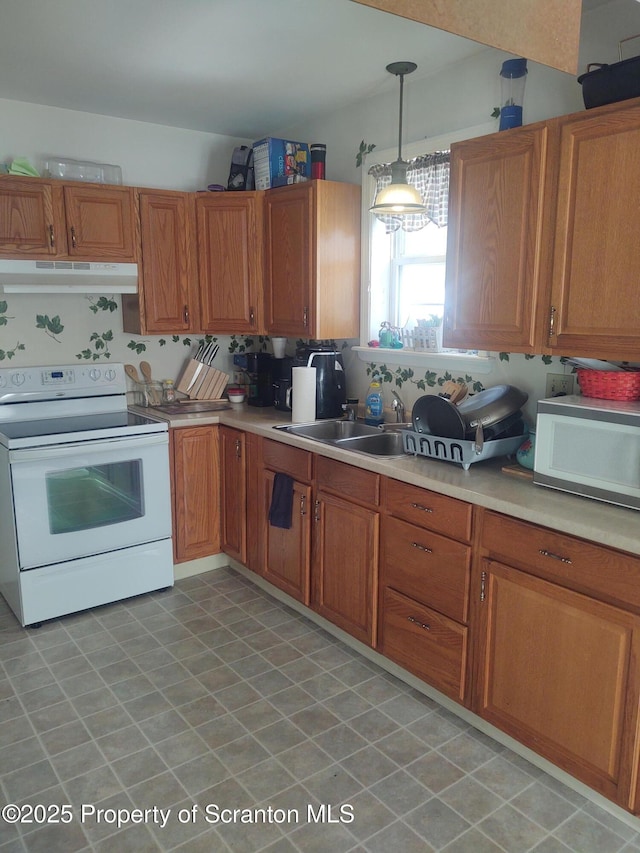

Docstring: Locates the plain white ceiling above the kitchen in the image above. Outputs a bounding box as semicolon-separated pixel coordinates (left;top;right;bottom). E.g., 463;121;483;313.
0;0;607;139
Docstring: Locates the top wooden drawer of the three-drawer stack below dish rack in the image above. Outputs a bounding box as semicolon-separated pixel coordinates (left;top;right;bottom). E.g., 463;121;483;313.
386;479;472;542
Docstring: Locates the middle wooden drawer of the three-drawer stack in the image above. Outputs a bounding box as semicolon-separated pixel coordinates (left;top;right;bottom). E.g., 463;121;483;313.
382;510;471;622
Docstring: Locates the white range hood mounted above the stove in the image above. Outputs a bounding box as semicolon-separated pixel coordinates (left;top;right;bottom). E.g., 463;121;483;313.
0;260;138;294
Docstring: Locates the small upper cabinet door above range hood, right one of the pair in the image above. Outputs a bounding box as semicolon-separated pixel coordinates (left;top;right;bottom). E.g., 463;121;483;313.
64;184;138;263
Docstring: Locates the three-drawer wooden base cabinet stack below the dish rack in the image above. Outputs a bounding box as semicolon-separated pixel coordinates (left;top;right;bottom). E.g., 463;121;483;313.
378;480;473;704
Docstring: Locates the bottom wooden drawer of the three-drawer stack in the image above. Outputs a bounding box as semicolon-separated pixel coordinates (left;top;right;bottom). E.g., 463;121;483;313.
379;588;467;702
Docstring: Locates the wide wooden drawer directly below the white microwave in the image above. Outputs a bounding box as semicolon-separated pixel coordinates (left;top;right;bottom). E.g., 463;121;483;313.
482;512;640;612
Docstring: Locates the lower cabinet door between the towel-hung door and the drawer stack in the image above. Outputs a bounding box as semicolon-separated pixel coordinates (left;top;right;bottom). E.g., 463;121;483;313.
312;492;380;646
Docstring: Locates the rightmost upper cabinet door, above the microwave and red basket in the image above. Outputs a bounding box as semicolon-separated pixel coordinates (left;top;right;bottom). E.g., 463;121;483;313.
550;103;640;359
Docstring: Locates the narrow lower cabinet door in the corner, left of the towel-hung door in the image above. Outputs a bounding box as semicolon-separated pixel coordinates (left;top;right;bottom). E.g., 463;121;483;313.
220;426;247;563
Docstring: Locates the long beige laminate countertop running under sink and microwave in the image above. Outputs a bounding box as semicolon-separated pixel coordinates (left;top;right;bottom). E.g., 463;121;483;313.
132;403;640;555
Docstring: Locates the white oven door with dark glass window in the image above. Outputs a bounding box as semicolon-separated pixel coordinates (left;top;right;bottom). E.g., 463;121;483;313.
9;432;171;570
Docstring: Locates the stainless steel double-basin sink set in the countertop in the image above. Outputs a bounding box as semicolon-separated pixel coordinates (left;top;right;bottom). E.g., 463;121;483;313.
275;420;405;456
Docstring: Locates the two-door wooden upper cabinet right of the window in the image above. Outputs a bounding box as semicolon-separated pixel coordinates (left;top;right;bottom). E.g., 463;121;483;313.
444;100;640;359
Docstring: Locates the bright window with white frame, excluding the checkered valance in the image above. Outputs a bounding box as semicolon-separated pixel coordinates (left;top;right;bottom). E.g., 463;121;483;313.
361;123;495;346
